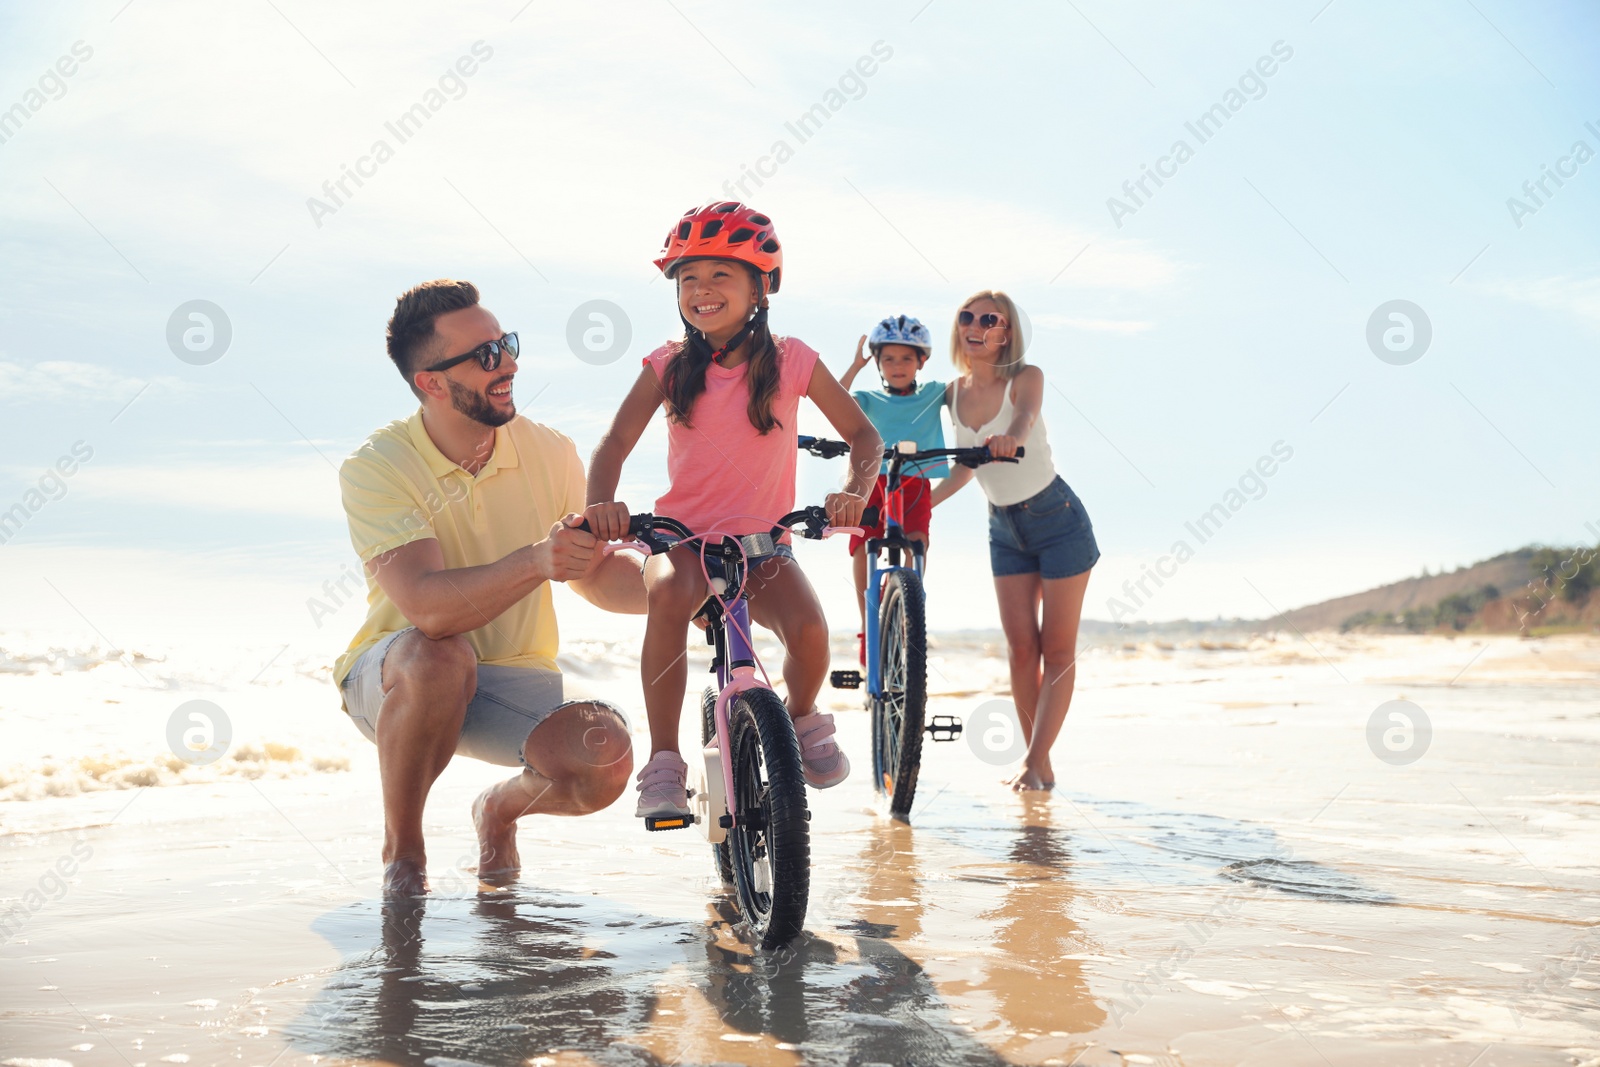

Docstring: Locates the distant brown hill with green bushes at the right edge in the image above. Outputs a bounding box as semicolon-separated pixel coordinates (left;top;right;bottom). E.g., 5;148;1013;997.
1267;545;1600;633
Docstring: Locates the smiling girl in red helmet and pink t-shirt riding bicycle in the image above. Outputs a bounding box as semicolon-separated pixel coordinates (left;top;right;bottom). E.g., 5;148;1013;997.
584;202;882;817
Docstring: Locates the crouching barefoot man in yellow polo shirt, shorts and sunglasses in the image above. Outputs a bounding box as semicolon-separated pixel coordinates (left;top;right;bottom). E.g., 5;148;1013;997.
333;280;645;896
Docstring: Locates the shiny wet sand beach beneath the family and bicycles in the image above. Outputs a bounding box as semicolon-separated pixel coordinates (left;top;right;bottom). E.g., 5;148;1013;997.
0;635;1600;1067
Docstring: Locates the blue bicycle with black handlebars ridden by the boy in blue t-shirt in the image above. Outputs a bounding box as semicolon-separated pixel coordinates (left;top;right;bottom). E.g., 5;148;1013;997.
798;435;1022;822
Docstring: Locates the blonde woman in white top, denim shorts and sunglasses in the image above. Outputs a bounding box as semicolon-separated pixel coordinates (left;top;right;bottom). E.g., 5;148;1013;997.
933;290;1099;790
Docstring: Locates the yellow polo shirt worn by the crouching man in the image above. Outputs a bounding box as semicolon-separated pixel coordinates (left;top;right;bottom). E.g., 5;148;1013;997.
333;410;584;683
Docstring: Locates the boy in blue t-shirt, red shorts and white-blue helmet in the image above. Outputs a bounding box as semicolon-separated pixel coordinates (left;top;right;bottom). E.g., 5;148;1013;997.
838;315;950;667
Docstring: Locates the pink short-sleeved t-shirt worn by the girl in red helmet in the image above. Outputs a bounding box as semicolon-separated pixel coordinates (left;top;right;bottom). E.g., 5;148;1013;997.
645;338;818;534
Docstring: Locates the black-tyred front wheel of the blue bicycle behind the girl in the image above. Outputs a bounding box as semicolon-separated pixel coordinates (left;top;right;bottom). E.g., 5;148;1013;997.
872;568;928;822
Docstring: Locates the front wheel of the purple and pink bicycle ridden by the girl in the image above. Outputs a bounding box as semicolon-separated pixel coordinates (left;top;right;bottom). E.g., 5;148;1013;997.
728;689;811;949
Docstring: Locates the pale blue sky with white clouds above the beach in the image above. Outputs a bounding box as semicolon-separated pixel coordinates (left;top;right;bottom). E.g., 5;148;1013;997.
0;0;1600;651
